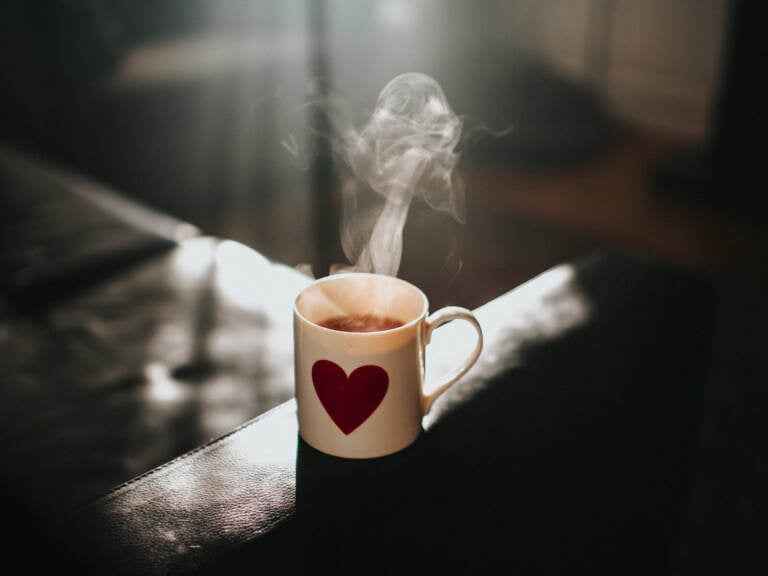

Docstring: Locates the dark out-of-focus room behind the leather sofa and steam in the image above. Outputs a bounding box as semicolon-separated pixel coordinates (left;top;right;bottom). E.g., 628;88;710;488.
0;0;768;573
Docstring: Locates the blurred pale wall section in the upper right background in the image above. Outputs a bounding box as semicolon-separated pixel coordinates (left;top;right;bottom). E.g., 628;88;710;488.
504;0;728;139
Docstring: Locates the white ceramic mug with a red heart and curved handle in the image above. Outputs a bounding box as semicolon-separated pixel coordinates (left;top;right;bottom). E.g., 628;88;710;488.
294;273;483;458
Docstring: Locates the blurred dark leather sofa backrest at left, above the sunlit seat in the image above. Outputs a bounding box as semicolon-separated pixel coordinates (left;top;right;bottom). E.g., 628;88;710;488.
0;143;198;307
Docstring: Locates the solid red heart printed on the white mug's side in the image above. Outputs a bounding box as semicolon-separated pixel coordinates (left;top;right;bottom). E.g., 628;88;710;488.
312;360;389;434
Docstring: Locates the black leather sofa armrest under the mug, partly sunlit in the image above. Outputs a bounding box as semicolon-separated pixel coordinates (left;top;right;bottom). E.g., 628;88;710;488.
61;249;712;574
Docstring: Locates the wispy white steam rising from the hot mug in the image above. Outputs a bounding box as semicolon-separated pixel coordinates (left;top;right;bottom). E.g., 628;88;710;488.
334;73;464;276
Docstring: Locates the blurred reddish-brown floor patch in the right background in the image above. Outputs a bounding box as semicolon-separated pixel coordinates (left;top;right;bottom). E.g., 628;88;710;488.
472;131;766;274
